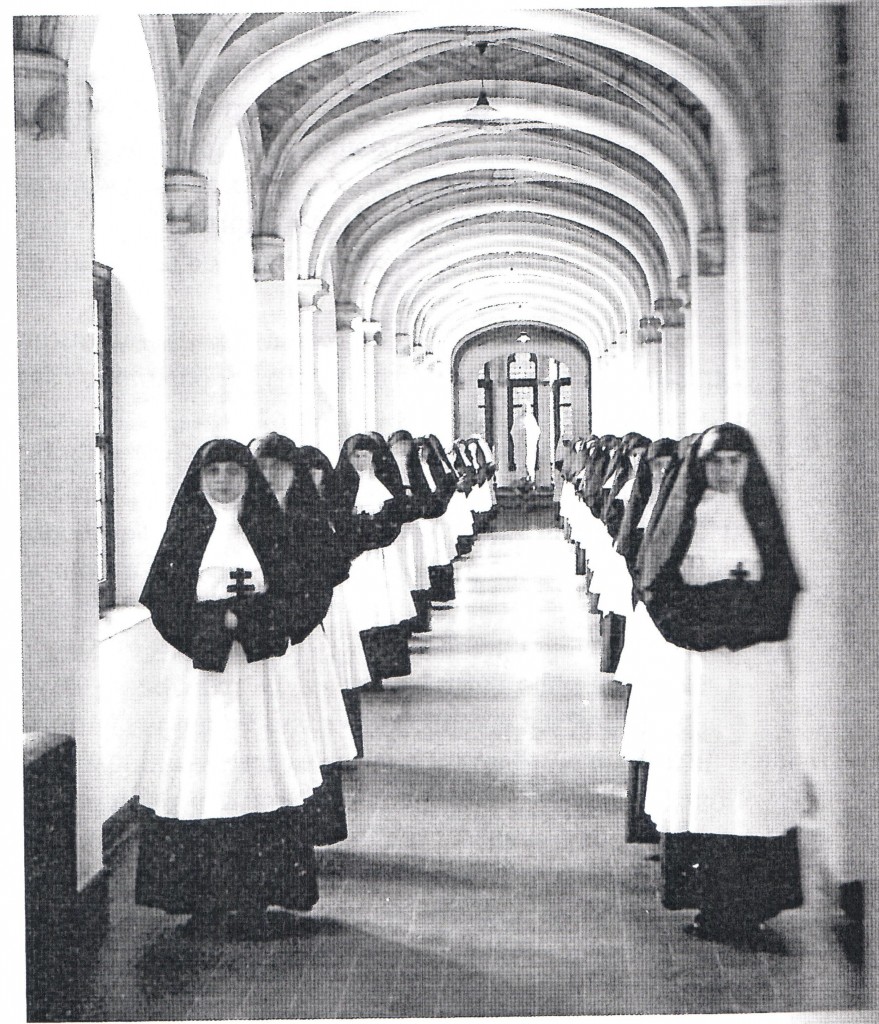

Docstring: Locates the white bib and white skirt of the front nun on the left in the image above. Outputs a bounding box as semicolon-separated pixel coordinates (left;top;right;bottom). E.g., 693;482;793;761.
138;502;325;819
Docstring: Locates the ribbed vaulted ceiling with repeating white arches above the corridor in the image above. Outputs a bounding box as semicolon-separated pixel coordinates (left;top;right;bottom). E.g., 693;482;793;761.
160;6;773;352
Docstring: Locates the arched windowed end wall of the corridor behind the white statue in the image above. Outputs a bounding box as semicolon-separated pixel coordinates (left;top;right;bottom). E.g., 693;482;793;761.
452;322;592;487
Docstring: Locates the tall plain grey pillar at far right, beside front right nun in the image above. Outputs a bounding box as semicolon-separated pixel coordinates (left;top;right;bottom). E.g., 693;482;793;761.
767;6;852;929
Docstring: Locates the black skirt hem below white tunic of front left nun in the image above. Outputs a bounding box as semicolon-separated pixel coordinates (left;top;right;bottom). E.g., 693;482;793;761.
134;807;318;913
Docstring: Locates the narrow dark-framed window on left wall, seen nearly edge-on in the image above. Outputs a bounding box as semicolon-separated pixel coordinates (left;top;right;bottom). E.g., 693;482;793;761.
92;262;116;614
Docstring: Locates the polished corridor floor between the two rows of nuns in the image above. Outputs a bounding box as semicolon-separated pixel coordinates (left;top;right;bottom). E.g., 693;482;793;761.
82;517;861;1020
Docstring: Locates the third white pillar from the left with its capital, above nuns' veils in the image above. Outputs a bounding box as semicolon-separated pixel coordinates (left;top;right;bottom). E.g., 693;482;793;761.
245;234;301;440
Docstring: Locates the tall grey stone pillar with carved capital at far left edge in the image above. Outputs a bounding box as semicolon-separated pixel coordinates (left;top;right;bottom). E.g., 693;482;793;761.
16;39;101;886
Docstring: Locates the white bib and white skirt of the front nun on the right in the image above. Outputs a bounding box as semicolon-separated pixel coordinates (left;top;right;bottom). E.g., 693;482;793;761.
646;489;806;837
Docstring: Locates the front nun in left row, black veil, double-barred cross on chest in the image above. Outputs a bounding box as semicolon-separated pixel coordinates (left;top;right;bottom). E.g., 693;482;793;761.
135;439;322;934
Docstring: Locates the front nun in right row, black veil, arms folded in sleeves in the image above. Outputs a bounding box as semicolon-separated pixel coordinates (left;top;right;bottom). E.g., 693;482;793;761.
639;423;806;947
